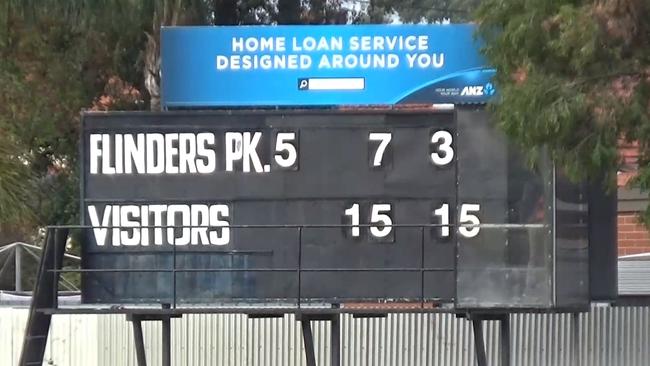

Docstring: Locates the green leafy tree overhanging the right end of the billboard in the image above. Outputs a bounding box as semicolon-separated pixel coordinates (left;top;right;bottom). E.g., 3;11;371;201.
470;0;650;223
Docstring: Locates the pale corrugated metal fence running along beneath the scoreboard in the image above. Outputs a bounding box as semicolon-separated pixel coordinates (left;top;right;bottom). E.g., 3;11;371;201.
0;307;650;366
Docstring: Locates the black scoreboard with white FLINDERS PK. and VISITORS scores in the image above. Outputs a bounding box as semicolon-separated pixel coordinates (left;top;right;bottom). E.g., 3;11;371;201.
82;109;604;307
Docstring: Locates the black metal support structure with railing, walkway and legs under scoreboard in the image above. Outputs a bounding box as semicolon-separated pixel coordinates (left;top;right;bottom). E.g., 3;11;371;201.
19;224;596;366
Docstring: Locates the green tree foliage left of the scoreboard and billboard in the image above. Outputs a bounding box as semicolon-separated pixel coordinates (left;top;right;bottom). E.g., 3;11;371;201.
0;1;144;234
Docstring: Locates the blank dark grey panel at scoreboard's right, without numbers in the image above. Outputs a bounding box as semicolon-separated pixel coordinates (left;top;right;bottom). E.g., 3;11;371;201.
457;110;554;308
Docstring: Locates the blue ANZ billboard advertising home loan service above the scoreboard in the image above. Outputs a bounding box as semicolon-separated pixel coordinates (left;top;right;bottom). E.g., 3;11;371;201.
161;24;495;108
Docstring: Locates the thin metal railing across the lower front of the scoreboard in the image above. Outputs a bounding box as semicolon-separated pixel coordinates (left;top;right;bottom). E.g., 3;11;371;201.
41;223;549;313
